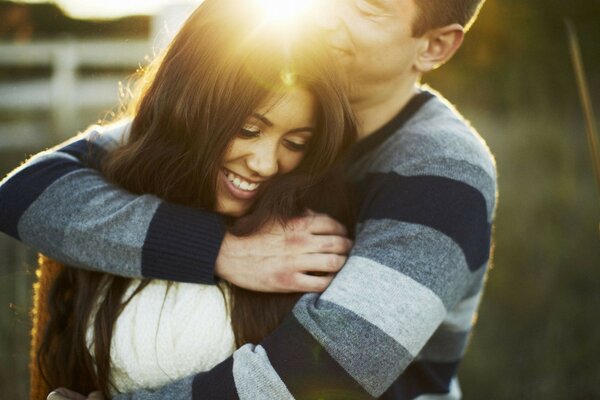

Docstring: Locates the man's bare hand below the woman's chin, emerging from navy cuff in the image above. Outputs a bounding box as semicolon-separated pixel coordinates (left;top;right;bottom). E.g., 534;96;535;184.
215;212;352;293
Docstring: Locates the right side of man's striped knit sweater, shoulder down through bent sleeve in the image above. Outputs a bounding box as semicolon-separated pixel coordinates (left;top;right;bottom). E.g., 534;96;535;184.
186;91;496;400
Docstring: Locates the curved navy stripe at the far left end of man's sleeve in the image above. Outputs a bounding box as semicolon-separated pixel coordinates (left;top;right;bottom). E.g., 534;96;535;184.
0;159;82;240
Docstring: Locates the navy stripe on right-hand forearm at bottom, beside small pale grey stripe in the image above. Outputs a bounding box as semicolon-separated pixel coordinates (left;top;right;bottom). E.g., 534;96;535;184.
261;316;373;400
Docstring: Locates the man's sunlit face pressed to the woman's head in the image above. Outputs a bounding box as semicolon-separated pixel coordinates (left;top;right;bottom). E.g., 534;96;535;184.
315;0;419;95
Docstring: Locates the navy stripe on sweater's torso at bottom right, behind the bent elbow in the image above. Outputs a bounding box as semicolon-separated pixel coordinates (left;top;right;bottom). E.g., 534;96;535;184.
380;361;460;400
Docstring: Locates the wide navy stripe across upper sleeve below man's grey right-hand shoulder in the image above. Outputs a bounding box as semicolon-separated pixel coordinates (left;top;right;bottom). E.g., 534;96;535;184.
356;172;492;271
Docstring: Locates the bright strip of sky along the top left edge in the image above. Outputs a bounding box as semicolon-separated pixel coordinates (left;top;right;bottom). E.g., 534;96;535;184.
21;0;202;18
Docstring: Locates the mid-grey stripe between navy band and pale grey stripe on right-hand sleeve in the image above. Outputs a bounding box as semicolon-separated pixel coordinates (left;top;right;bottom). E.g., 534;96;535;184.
354;220;479;309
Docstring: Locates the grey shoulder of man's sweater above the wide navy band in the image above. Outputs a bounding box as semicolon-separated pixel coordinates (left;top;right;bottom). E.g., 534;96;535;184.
351;93;497;218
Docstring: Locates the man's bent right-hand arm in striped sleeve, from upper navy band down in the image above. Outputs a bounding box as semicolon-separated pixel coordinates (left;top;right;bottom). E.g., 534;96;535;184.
108;148;496;400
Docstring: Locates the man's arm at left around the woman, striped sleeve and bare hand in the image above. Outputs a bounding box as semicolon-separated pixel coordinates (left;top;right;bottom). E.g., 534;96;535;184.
0;121;351;292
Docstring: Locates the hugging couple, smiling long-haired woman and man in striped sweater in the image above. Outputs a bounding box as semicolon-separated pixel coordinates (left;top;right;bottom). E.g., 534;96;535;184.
0;0;496;399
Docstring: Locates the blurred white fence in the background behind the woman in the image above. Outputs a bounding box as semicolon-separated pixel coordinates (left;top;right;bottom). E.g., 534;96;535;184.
0;39;152;149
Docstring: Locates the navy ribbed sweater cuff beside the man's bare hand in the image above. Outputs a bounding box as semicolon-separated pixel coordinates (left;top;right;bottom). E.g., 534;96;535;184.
142;203;225;285
